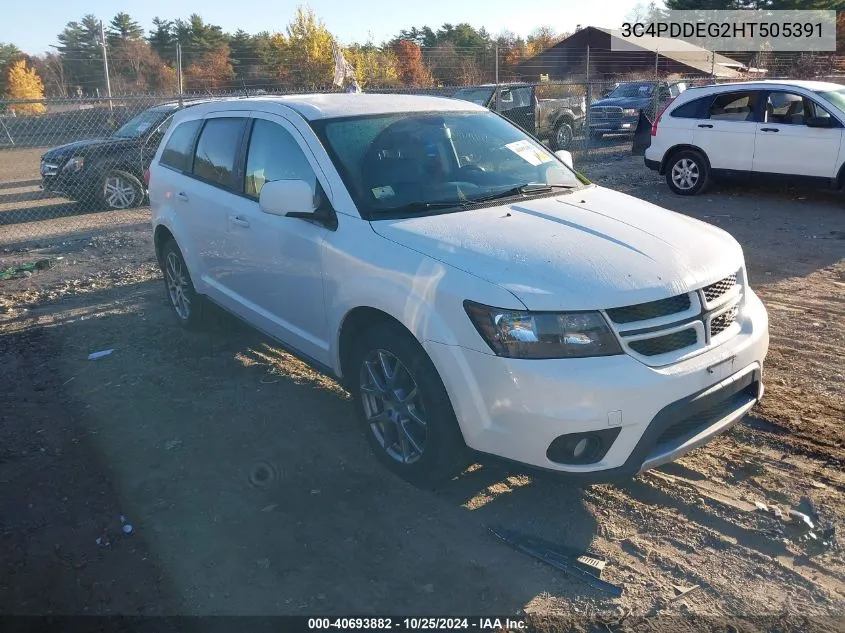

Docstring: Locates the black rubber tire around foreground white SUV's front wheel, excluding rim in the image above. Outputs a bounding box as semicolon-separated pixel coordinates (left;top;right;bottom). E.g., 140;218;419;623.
348;323;470;488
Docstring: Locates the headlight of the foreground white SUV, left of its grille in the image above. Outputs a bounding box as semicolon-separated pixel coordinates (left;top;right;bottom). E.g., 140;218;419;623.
464;301;622;358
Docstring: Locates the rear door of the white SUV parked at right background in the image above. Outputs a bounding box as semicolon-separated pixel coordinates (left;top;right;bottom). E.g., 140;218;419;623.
693;90;761;172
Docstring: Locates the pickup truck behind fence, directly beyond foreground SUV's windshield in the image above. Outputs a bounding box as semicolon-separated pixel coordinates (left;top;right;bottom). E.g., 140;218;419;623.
454;83;587;150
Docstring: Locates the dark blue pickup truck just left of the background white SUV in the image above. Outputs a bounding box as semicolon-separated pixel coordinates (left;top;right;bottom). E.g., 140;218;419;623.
590;81;686;138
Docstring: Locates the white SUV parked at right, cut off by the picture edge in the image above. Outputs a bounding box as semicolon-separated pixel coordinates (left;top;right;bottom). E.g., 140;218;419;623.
645;81;845;195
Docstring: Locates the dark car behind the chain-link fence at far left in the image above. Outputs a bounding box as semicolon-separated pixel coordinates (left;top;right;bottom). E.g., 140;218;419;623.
41;102;207;209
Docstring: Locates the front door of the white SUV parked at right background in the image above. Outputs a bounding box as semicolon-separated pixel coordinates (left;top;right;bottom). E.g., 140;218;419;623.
754;90;843;178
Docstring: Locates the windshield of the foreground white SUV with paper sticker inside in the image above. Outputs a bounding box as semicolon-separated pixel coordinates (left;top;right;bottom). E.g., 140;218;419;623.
314;112;588;219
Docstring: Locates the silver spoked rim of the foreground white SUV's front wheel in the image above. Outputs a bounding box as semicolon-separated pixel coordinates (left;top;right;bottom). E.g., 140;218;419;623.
360;349;428;464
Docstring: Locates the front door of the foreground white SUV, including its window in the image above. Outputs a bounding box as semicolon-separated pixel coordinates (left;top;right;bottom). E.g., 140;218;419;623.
219;113;330;364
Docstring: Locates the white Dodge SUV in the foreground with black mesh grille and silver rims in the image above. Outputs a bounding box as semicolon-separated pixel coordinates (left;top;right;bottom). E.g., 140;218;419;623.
147;94;769;484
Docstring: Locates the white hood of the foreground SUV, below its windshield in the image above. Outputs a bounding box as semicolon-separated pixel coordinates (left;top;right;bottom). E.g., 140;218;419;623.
371;186;743;310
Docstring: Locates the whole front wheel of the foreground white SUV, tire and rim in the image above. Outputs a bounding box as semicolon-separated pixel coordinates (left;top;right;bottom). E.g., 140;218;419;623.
350;324;469;487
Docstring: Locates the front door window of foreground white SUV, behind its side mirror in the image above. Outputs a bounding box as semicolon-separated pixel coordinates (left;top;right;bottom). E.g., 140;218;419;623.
244;119;317;198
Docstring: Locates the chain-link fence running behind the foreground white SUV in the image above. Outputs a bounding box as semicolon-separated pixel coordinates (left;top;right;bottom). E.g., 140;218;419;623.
0;74;840;247
